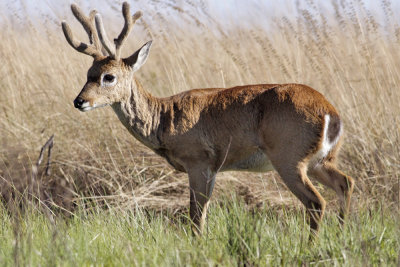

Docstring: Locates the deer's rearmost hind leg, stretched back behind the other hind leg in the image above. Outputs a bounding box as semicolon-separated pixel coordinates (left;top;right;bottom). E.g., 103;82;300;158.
309;162;354;222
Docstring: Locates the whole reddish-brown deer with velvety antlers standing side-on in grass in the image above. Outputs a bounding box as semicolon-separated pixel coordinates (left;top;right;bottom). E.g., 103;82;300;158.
62;2;354;235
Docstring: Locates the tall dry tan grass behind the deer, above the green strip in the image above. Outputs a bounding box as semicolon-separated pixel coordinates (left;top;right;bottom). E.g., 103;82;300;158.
0;0;400;214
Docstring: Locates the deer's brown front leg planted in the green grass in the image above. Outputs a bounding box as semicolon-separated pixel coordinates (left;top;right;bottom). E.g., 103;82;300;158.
188;168;216;235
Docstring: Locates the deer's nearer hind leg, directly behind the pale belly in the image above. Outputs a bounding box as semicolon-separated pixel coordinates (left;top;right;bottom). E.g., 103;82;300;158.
275;162;326;234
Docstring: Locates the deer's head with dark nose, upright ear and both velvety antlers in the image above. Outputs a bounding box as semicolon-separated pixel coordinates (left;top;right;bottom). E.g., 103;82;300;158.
62;2;152;111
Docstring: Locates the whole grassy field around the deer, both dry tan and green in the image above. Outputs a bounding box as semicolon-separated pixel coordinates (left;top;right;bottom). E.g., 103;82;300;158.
0;0;400;266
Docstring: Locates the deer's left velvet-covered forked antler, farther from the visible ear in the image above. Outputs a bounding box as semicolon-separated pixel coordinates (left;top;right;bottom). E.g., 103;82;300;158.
61;4;103;58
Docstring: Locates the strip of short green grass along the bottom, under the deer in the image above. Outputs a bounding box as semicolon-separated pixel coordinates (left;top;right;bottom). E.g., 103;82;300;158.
0;198;400;266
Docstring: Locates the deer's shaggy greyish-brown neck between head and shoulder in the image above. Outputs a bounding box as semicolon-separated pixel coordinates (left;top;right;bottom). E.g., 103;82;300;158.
112;79;161;150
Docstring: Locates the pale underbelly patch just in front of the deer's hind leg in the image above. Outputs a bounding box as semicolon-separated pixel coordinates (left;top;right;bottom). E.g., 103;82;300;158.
226;150;274;172
